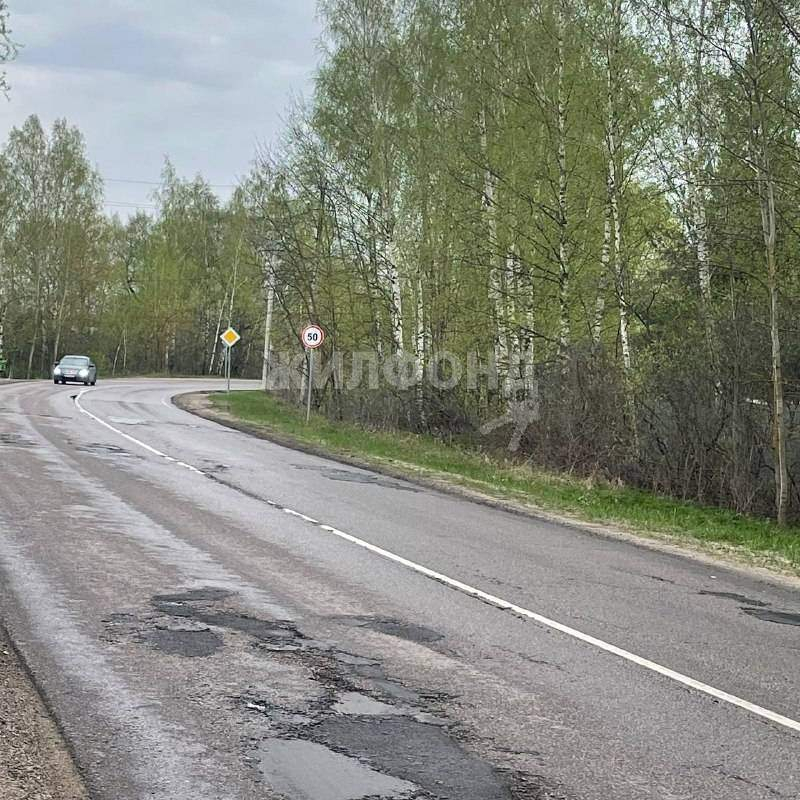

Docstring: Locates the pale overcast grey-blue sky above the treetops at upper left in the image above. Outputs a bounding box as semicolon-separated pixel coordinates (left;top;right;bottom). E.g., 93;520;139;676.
0;0;320;216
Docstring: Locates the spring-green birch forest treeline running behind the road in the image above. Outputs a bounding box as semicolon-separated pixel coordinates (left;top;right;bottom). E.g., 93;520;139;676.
0;0;800;522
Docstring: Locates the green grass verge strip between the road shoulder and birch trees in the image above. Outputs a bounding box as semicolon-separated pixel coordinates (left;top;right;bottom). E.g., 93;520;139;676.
211;391;800;575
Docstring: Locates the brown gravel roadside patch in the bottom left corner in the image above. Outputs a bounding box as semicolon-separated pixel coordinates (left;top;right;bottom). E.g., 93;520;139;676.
0;626;89;800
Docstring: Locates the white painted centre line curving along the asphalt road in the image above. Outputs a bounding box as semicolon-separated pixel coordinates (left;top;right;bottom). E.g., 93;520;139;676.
75;389;800;732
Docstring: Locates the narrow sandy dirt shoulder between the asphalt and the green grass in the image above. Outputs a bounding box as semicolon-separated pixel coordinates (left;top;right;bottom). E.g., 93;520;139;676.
172;391;800;590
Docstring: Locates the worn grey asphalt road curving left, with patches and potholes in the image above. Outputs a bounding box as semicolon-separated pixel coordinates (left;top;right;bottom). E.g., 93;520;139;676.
0;380;800;800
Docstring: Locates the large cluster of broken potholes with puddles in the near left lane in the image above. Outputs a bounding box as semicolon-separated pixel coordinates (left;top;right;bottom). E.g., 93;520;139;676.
133;587;560;800
